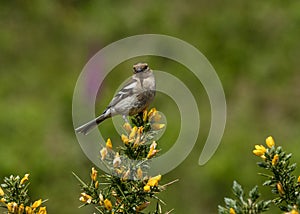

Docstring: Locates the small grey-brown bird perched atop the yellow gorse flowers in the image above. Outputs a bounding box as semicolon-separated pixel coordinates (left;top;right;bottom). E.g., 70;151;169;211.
75;63;155;135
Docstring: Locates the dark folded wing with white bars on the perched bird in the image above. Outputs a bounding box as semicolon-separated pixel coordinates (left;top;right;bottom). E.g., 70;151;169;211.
107;79;138;108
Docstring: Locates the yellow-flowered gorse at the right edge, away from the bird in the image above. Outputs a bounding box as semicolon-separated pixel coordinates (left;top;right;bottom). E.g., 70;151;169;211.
219;137;300;214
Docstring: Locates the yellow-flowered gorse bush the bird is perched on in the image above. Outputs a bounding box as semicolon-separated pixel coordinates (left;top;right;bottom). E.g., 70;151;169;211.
74;108;173;214
